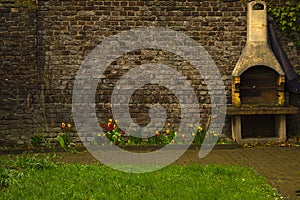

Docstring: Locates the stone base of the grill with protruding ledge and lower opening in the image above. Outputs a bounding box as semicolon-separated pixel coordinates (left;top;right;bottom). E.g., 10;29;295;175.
227;105;298;144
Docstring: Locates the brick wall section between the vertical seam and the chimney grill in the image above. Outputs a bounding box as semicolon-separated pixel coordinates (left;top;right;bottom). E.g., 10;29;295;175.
37;1;246;144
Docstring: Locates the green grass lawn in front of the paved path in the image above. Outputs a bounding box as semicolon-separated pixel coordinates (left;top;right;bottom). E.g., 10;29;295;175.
0;155;280;200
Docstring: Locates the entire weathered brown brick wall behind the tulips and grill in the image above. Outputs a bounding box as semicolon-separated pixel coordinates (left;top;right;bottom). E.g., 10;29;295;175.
0;0;300;147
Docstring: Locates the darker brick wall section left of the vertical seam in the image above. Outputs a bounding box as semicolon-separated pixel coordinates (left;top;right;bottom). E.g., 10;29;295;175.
0;1;38;146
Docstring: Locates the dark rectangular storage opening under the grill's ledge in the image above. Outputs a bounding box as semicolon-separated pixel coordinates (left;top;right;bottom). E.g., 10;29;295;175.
241;115;278;139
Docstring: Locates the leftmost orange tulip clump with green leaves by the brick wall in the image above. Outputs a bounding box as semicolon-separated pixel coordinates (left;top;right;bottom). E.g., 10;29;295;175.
56;122;75;150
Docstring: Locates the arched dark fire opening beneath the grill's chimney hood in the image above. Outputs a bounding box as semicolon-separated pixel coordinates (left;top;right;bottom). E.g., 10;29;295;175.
240;66;279;105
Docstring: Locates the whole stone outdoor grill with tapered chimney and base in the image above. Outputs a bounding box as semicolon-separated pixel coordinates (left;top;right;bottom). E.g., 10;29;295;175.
227;1;297;143
